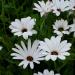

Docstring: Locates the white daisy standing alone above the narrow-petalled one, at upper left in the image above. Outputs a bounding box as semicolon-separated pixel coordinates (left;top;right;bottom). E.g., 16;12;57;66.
9;17;37;39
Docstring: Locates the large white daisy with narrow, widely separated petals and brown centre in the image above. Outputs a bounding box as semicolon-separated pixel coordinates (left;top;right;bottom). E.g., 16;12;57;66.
11;39;44;69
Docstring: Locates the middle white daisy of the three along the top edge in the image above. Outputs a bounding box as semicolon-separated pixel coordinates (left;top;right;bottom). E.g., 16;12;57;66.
52;0;70;16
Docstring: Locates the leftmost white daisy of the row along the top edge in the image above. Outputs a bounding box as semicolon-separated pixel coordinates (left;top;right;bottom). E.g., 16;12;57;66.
33;0;52;17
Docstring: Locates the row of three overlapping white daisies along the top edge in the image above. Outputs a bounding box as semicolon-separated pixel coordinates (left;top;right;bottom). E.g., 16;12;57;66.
33;0;75;17
